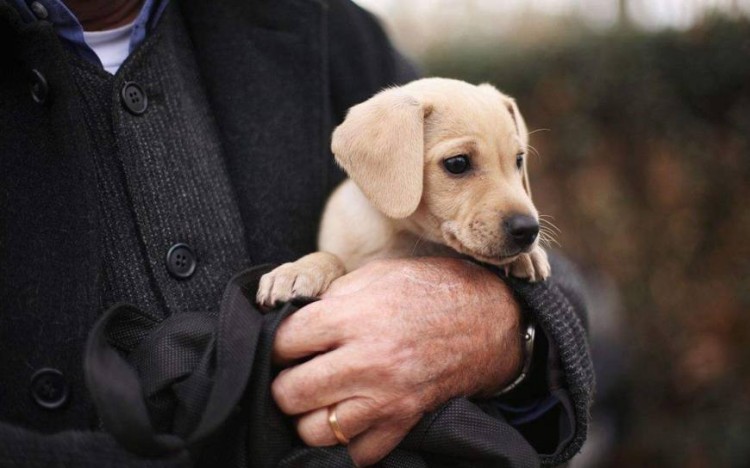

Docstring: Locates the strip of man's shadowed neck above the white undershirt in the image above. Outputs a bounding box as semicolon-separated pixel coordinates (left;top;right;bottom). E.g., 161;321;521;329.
64;0;143;31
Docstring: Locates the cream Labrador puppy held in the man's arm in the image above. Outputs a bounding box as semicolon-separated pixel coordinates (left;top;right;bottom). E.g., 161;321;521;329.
257;78;550;306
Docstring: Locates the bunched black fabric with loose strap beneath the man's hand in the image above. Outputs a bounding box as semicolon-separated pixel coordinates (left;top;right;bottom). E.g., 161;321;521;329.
85;266;539;468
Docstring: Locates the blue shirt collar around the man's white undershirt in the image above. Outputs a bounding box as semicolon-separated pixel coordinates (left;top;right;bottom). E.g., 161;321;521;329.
10;0;169;67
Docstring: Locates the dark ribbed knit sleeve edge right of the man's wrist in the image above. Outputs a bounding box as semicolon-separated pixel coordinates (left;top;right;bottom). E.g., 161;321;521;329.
508;255;594;465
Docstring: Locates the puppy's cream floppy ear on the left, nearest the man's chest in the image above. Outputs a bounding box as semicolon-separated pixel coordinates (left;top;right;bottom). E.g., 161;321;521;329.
331;88;426;218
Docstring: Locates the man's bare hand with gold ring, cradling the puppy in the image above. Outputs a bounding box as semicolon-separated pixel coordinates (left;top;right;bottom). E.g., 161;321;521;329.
272;258;521;465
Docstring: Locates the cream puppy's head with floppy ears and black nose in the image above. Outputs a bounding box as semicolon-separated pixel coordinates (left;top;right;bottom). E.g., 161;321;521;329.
331;78;539;265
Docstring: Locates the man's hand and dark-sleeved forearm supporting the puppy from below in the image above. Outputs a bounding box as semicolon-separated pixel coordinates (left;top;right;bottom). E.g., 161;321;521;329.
273;254;591;464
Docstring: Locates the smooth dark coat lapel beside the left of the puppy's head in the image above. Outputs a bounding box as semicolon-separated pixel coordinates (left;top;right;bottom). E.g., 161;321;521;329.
181;0;331;263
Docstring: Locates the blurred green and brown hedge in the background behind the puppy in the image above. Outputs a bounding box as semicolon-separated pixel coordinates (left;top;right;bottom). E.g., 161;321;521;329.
424;18;750;466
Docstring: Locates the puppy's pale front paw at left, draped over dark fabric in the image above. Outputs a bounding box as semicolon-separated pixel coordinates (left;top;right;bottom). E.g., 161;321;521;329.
255;252;346;307
